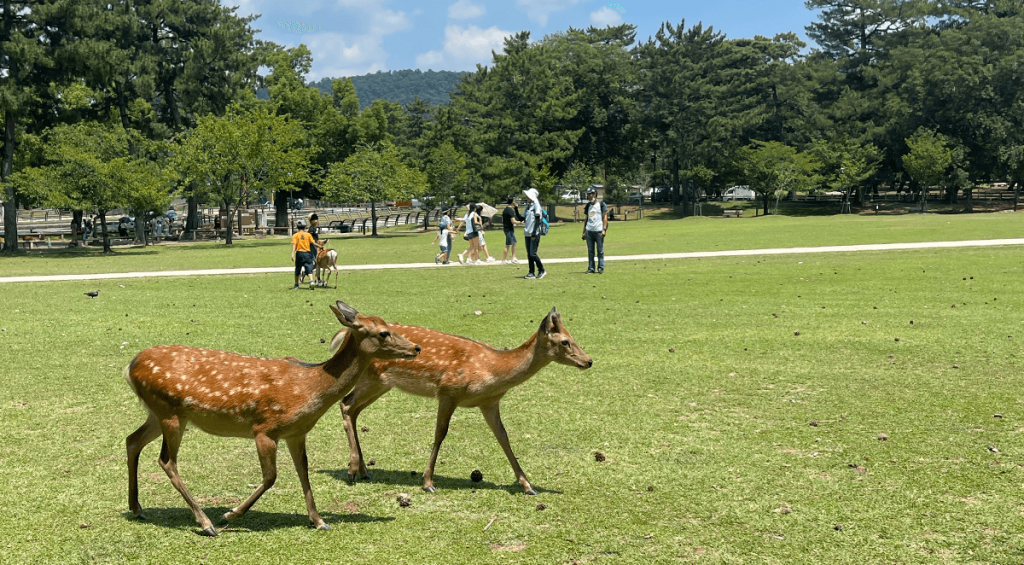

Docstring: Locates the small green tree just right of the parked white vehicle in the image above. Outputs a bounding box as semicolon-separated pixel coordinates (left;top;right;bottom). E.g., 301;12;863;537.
741;141;813;215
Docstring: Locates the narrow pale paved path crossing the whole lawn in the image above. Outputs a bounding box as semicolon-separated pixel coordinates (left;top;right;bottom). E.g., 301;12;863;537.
0;238;1024;284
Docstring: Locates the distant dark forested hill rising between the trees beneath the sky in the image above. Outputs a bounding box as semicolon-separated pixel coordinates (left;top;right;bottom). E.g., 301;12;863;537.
309;70;466;107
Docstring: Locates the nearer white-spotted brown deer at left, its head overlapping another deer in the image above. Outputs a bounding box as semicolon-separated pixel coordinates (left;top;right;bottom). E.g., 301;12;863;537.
125;301;421;536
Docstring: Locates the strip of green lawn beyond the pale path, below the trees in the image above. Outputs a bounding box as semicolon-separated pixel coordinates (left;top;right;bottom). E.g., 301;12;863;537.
0;213;1024;276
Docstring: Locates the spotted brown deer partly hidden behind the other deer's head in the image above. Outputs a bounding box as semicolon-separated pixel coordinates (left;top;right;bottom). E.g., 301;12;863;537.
332;308;594;494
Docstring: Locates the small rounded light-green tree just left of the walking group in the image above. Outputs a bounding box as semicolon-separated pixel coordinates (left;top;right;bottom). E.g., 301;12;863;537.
321;141;426;236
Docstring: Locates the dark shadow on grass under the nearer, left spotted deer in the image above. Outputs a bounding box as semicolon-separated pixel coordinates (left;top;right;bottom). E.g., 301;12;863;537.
121;507;394;533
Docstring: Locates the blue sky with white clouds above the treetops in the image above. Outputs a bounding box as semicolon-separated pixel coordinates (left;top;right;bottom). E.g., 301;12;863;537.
228;0;815;80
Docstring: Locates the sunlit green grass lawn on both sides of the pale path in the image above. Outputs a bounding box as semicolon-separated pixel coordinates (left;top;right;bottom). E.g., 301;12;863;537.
0;237;1024;564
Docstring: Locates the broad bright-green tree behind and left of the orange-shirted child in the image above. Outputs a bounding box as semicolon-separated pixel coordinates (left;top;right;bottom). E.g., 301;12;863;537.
174;102;313;245
